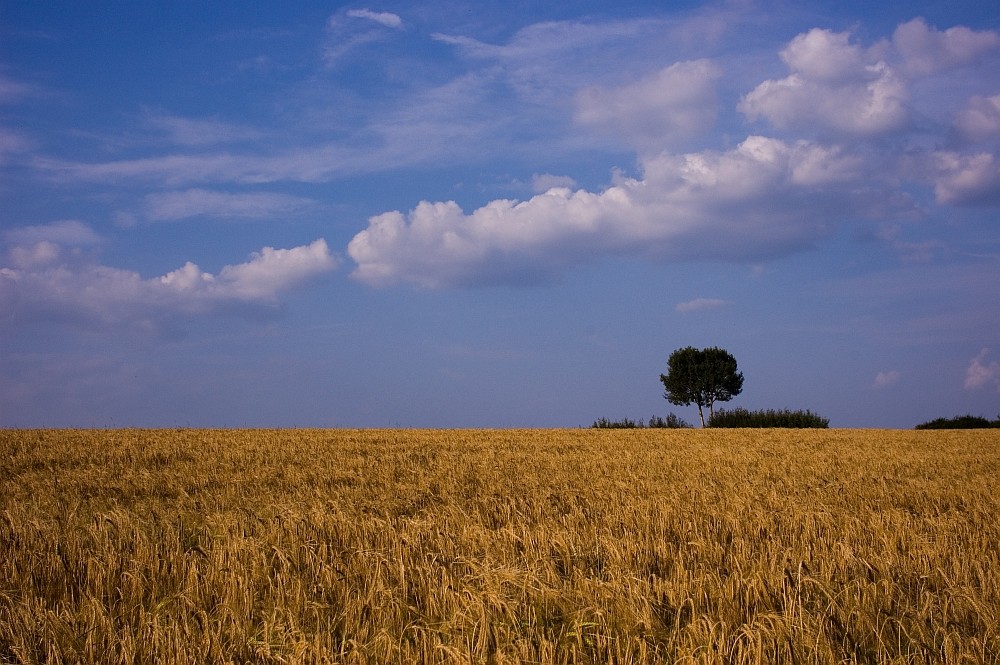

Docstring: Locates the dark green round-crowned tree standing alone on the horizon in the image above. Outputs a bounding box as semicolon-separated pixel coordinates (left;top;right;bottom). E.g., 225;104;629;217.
660;346;743;427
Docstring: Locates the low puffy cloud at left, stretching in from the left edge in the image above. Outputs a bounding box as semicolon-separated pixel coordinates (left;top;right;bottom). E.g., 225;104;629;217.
0;233;337;324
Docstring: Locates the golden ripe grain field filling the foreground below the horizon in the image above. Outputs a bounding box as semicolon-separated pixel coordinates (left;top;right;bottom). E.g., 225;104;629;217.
0;429;1000;664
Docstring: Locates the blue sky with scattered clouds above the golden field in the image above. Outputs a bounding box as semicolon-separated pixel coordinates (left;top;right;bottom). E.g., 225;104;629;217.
0;0;1000;427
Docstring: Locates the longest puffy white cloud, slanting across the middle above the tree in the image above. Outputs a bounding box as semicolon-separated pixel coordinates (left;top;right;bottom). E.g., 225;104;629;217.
348;136;858;288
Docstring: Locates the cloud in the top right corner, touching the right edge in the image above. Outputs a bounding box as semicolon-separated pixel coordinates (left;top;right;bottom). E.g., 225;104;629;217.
892;18;1000;76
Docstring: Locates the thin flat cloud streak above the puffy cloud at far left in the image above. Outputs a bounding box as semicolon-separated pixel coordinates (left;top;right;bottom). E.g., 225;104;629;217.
146;189;312;221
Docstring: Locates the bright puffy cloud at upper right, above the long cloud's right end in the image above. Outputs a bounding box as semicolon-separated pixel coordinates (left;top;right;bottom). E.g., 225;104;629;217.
738;28;909;136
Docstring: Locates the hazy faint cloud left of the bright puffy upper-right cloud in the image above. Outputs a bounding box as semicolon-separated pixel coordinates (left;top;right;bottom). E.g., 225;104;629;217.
574;60;721;153
